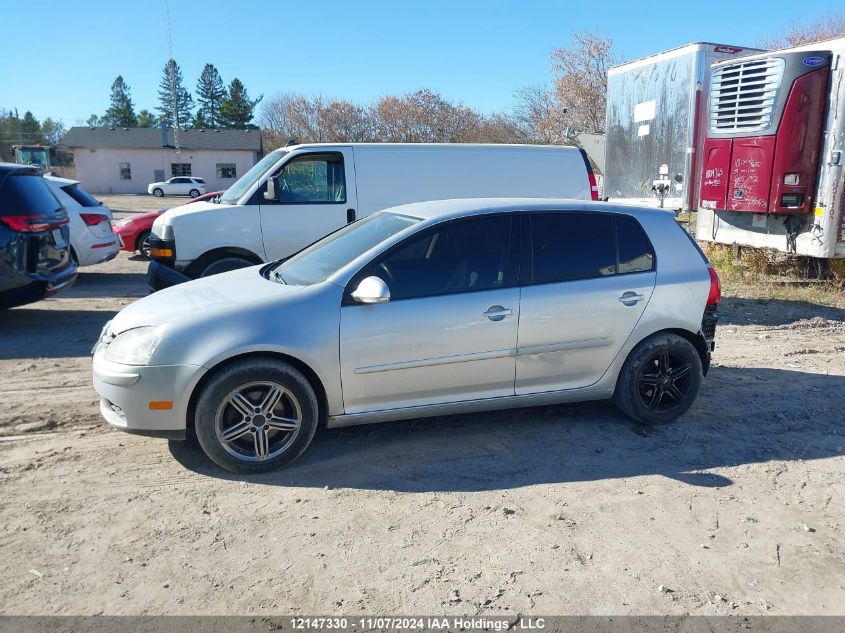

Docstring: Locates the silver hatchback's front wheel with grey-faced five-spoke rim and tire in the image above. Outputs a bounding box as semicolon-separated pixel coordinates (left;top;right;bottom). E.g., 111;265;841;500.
194;358;319;473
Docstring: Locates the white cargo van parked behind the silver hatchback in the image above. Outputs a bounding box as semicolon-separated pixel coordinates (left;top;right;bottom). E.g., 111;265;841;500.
148;143;598;290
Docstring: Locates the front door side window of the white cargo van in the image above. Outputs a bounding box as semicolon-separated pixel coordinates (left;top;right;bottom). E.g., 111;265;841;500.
278;153;346;204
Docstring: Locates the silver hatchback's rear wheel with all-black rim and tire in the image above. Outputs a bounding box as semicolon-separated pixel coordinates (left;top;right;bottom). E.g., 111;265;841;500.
613;333;704;424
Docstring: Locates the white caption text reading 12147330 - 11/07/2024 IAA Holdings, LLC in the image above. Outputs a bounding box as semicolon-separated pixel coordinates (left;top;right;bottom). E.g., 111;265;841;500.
290;616;546;631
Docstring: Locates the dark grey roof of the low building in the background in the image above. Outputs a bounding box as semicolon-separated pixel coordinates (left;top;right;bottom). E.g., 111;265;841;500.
59;127;261;152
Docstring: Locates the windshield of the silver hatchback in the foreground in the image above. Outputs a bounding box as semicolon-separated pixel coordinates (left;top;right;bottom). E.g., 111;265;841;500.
276;212;420;286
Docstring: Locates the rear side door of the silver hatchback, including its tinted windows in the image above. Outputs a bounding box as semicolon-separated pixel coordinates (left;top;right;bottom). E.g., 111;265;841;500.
516;210;656;395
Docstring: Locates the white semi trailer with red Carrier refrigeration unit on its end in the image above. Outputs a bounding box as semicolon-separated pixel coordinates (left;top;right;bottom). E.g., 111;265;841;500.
696;38;845;258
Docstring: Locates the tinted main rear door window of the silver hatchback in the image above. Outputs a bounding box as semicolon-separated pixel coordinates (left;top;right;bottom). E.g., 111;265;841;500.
530;213;616;284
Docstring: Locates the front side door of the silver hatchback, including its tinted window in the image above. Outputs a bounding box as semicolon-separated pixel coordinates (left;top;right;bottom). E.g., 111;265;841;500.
340;215;519;414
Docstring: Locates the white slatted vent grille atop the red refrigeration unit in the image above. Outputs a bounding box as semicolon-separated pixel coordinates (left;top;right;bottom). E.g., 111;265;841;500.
710;57;784;134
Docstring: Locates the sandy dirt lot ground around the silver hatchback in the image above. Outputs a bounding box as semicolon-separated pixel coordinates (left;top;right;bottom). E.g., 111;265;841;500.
0;199;845;615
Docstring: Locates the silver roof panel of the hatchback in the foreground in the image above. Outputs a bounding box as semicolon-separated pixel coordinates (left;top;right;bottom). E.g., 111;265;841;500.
385;198;674;220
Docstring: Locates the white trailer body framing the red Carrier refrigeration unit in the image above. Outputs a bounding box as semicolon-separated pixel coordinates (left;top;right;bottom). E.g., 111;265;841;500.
696;38;845;259
